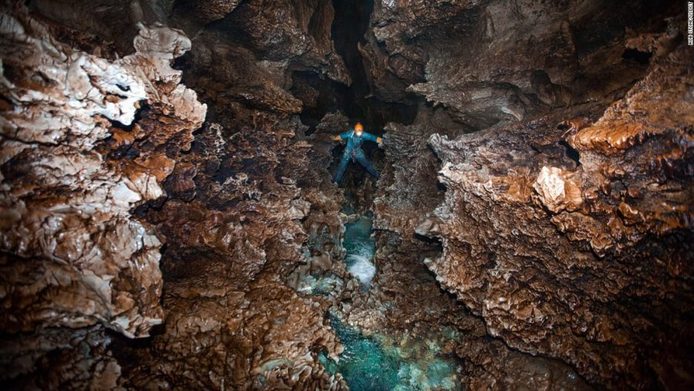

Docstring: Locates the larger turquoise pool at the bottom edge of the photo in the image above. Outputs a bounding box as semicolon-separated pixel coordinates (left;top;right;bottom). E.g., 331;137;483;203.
320;316;460;391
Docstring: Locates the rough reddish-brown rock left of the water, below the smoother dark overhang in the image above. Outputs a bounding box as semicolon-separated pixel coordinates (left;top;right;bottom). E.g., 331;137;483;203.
114;106;344;390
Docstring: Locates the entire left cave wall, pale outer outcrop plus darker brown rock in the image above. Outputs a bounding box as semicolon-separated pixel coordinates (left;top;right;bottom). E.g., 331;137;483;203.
1;1;349;390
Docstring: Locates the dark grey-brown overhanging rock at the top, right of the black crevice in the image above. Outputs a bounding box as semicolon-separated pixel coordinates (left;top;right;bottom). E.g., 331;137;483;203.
361;0;668;129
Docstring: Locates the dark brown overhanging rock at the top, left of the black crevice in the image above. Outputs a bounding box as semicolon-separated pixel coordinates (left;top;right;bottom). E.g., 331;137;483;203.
174;0;350;121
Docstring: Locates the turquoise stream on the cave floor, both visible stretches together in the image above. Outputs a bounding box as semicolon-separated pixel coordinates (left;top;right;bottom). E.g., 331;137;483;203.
320;213;460;391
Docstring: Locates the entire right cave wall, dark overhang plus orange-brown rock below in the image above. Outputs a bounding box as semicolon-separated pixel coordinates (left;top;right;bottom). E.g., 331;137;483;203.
362;1;692;388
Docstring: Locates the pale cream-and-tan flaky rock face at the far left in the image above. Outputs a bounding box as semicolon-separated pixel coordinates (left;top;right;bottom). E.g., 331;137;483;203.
0;2;206;388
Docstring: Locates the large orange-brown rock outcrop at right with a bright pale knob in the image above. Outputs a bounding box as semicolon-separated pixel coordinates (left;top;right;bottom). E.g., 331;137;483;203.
428;39;694;388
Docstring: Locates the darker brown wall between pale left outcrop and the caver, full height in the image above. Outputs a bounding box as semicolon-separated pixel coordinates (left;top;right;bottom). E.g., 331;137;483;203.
104;2;354;390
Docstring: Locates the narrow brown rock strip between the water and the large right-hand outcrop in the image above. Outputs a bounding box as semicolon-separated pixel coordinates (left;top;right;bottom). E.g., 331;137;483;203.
370;108;588;390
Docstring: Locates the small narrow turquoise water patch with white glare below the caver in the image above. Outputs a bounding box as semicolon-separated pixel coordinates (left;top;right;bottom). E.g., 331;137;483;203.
342;215;376;288
